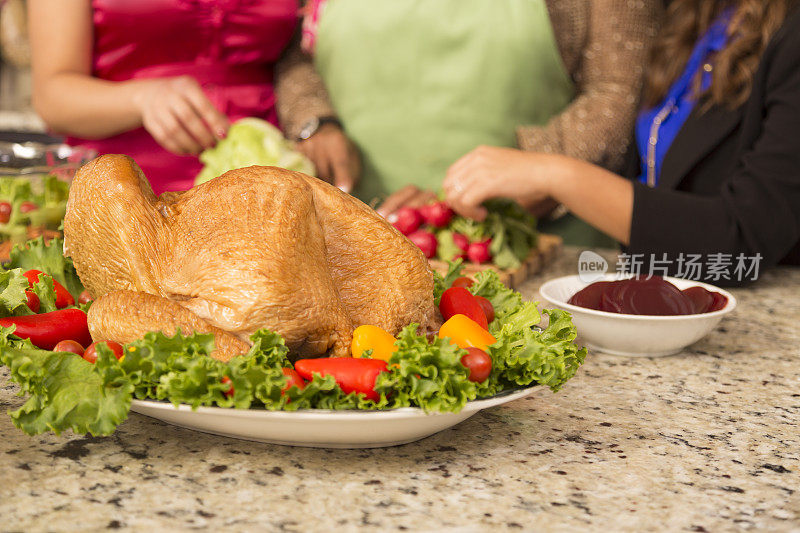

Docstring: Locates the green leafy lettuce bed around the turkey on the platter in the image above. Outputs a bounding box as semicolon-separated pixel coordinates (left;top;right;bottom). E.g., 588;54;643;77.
0;243;586;435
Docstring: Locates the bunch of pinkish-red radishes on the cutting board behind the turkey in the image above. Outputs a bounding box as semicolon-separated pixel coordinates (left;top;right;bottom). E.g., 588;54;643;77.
392;201;492;263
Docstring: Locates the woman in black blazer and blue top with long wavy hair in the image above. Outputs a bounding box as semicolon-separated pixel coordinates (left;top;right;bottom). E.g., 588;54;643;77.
445;0;800;284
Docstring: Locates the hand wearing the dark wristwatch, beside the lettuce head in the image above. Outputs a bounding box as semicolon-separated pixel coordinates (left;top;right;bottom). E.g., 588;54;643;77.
297;124;361;193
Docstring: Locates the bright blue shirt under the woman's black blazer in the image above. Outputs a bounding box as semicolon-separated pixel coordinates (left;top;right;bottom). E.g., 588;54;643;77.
636;9;732;183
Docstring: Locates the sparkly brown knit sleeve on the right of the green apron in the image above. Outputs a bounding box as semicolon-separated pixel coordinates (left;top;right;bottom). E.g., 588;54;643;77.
517;0;661;169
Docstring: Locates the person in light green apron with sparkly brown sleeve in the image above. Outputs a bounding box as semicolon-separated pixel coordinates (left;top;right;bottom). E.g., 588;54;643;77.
288;0;661;244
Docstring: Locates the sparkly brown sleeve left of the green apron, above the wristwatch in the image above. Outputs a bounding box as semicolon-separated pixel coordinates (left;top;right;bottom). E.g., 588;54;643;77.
275;30;336;139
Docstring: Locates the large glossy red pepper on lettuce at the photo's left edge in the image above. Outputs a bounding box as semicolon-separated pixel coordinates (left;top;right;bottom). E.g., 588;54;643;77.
0;309;92;350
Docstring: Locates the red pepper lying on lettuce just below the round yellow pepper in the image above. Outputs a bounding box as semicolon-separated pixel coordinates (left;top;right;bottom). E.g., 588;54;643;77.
294;357;387;402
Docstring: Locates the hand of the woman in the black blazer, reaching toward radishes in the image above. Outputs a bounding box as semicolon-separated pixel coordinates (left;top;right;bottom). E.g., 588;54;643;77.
444;146;553;220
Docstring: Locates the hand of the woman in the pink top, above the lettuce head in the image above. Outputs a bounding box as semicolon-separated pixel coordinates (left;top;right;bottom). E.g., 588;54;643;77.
134;76;230;155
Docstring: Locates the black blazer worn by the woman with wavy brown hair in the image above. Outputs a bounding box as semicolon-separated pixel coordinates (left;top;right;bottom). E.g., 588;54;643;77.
626;9;800;284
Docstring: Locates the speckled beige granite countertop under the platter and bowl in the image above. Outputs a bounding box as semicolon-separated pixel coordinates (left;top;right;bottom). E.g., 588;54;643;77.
0;249;800;531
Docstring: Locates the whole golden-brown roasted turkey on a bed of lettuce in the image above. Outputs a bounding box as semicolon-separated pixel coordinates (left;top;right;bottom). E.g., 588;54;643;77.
64;155;435;360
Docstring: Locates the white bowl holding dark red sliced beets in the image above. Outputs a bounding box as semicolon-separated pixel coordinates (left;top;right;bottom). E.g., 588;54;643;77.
539;274;736;357
